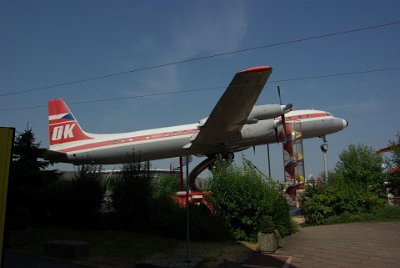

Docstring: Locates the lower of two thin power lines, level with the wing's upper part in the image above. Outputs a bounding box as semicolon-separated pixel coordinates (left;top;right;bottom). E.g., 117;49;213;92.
0;66;400;111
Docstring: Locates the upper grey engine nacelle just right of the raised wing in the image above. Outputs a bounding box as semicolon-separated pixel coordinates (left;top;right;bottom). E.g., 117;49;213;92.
246;104;292;124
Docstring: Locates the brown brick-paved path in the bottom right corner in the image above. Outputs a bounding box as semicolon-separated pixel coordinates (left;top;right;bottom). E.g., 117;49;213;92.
274;221;400;268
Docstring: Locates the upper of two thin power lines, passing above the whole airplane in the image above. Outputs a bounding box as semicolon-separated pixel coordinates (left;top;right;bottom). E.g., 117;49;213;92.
0;21;400;97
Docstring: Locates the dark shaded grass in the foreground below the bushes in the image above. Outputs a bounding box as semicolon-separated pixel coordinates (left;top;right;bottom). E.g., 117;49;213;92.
7;228;255;268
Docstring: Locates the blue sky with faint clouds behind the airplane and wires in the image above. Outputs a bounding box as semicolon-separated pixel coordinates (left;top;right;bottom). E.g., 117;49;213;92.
0;0;400;179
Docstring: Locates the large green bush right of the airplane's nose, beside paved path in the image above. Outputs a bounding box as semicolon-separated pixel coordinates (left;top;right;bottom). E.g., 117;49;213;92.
300;145;387;225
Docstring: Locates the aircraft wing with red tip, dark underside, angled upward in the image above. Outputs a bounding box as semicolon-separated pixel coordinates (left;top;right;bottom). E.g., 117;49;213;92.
185;66;272;151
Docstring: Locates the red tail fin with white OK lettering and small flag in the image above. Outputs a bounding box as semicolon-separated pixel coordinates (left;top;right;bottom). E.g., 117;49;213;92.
48;99;92;149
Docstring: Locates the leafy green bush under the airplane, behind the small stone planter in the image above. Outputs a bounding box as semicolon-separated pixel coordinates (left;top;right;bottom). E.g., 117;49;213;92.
209;161;293;241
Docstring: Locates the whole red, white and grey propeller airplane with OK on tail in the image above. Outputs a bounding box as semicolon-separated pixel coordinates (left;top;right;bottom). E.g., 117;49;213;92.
45;66;348;185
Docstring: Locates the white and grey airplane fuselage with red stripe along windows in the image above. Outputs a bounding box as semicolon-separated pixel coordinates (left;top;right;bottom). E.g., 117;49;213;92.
52;110;348;164
